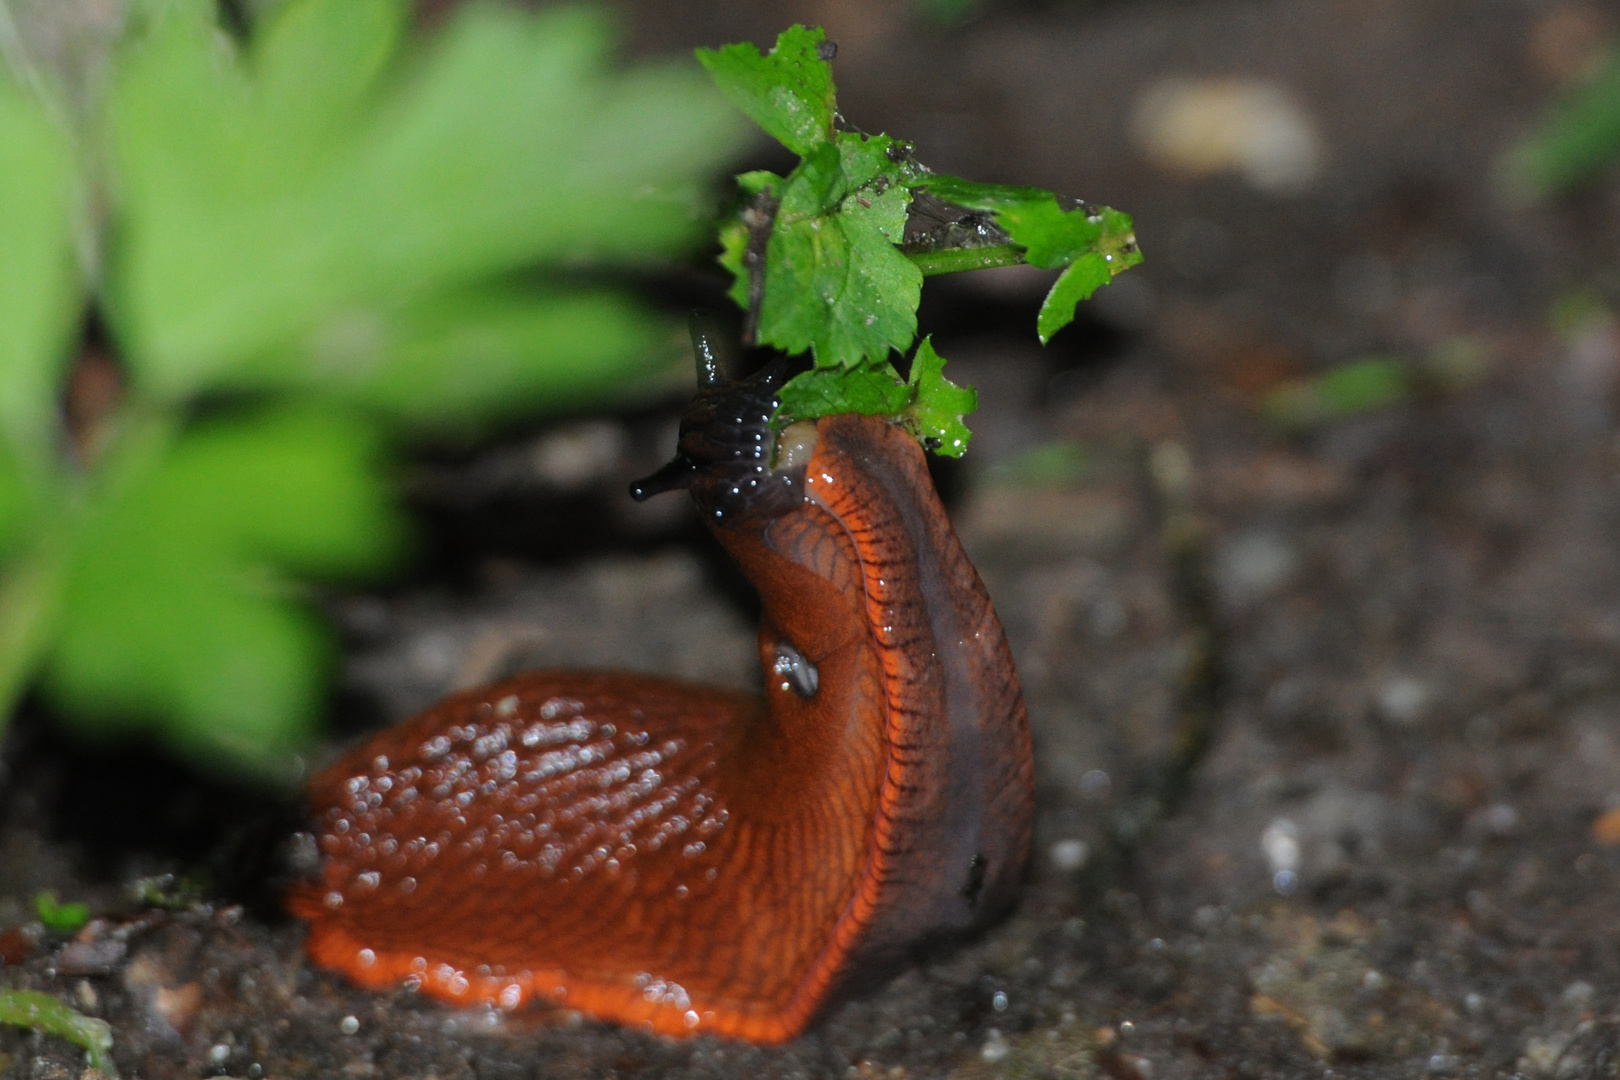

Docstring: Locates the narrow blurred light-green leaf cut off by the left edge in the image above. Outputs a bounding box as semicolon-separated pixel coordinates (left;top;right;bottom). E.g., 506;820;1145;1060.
0;70;84;472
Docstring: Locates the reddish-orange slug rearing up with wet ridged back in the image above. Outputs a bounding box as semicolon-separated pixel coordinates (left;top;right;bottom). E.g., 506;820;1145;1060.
288;351;1034;1043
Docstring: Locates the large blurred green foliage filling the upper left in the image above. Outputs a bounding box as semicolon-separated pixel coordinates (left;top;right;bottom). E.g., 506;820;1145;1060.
0;0;744;771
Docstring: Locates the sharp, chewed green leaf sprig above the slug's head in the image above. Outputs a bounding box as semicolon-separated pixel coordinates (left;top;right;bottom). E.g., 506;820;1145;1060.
698;26;1142;457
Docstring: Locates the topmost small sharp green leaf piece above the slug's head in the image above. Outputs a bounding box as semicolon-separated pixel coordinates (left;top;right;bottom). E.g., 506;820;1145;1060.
697;24;838;157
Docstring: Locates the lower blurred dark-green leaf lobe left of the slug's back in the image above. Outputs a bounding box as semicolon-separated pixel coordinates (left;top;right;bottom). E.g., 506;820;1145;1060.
44;408;400;767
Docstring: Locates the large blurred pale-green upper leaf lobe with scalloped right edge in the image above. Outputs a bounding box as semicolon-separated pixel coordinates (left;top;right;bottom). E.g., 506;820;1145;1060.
109;0;740;400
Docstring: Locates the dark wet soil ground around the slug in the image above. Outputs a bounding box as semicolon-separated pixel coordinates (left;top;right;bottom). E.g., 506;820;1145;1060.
9;0;1620;1080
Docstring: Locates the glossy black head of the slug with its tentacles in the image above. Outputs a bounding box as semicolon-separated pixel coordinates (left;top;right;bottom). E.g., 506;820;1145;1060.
630;325;815;525
